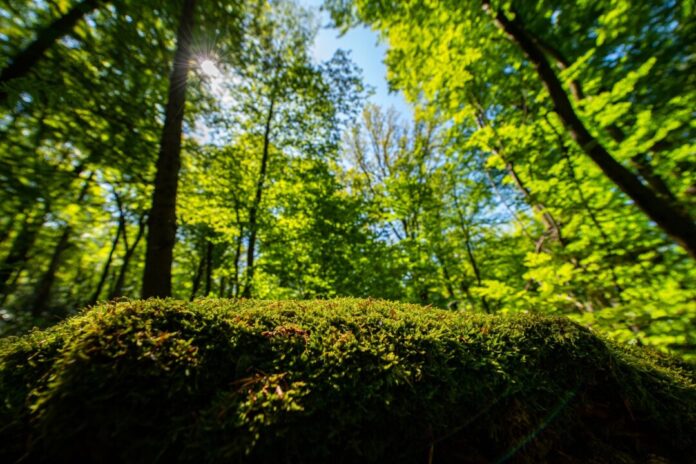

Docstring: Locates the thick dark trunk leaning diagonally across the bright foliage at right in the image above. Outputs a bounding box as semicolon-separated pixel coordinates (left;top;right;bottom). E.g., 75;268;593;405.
483;0;696;259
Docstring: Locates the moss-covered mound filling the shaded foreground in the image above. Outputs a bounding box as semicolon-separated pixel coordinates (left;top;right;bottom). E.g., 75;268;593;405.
0;300;696;463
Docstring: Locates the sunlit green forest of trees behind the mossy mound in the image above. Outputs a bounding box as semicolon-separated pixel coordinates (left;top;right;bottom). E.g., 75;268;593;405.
0;0;696;359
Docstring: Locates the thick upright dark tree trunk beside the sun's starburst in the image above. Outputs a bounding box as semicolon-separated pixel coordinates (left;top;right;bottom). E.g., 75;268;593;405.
142;0;196;298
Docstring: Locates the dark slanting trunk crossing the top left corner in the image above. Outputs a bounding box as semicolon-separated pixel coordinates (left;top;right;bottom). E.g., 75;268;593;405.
0;0;99;104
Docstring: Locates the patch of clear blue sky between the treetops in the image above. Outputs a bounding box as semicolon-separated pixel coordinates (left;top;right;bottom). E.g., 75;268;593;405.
300;0;411;115
